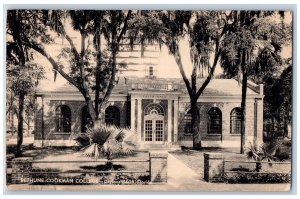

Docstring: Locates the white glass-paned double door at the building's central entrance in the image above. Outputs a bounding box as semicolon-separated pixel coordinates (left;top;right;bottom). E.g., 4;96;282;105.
144;115;164;144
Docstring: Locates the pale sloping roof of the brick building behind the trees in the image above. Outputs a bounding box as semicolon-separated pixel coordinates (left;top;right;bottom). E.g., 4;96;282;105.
37;77;263;96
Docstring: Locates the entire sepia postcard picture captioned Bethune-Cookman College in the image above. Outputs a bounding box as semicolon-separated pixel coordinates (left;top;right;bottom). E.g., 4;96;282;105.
3;6;296;192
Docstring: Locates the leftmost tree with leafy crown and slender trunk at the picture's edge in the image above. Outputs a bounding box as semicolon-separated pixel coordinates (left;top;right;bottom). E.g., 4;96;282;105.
6;10;48;157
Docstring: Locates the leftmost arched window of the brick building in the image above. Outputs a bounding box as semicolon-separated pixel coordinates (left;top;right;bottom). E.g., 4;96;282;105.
55;105;71;132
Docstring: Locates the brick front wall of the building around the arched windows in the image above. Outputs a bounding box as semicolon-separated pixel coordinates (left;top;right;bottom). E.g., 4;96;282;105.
35;97;263;146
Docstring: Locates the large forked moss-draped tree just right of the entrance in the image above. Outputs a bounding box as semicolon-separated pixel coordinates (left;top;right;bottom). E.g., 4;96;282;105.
130;11;240;149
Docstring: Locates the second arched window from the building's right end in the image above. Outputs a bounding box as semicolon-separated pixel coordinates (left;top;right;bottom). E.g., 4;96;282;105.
207;107;222;134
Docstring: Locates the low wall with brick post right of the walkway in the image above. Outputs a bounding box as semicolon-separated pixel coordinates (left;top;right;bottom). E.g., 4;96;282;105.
204;153;291;183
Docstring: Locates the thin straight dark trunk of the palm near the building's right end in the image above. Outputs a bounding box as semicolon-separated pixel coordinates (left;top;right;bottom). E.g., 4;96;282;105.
240;72;247;154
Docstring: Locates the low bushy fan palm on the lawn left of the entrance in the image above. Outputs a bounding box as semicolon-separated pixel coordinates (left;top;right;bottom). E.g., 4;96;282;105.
75;125;136;160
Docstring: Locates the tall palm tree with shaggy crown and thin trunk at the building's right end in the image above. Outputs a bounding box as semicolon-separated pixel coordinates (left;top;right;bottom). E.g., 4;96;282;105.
221;11;291;153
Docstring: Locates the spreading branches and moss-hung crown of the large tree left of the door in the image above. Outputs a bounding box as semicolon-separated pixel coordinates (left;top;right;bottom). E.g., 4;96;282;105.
11;10;131;122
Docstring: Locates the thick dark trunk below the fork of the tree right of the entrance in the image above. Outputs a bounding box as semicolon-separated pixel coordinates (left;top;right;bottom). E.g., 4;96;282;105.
191;99;201;149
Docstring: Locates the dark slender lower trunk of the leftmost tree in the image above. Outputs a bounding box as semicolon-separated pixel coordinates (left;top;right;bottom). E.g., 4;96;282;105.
16;93;25;157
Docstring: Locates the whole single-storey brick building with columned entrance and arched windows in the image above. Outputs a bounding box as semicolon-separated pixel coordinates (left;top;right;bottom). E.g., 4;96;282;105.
34;75;263;149
